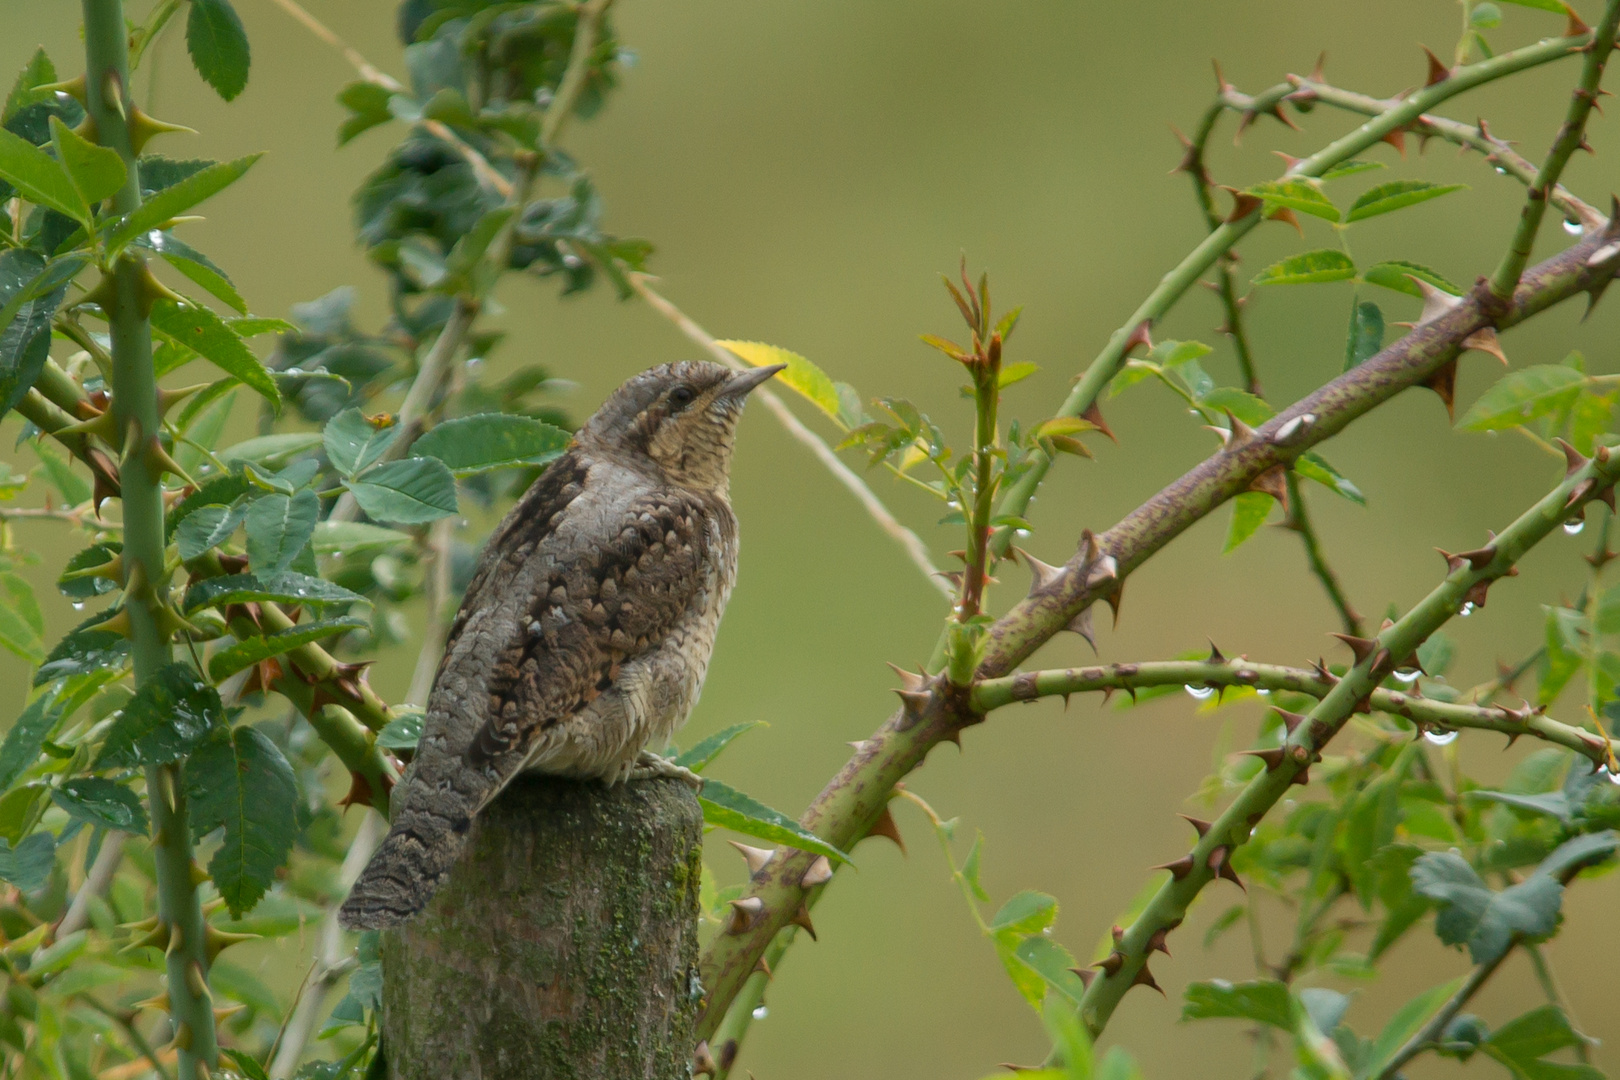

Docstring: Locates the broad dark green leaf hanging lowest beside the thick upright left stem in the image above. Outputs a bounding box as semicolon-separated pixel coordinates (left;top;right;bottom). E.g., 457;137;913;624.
186;725;298;918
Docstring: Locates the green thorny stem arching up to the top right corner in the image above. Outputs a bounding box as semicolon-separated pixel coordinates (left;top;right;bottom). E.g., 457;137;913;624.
995;25;1592;555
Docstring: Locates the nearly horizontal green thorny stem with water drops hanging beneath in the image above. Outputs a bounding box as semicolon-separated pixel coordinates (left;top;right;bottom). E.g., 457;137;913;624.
972;659;1607;764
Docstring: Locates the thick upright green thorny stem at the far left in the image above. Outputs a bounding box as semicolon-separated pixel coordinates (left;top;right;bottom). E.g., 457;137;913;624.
84;0;219;1080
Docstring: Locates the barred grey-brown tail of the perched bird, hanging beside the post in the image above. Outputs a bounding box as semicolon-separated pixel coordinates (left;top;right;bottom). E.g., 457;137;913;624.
337;785;473;929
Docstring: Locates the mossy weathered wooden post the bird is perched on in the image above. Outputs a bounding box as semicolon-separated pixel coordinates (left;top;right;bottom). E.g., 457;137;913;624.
382;777;703;1080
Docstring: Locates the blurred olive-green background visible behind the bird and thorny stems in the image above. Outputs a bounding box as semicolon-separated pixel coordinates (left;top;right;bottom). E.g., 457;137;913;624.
0;0;1620;1080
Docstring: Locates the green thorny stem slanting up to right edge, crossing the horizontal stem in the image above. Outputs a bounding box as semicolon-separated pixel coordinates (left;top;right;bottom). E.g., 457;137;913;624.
1081;455;1620;1036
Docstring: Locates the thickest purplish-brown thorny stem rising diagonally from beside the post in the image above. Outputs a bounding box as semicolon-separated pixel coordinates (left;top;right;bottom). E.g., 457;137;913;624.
686;223;1620;1038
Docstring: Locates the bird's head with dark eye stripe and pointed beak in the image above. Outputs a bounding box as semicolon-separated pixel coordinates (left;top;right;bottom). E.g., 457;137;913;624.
578;361;782;492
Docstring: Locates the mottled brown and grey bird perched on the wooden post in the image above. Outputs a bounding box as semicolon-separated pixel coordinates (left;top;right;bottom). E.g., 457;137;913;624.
339;361;782;929
